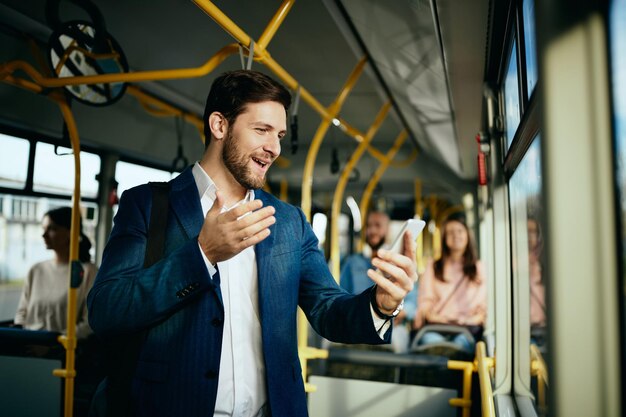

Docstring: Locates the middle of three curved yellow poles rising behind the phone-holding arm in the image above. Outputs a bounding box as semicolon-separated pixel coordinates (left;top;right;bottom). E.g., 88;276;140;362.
330;101;391;282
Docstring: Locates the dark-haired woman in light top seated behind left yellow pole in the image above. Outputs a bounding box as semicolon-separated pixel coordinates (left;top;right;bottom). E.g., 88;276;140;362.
14;207;97;339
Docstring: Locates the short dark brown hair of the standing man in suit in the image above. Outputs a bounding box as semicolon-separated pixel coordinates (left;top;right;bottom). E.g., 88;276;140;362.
204;70;291;148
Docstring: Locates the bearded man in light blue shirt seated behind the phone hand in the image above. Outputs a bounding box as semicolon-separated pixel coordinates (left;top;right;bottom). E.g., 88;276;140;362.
339;210;417;353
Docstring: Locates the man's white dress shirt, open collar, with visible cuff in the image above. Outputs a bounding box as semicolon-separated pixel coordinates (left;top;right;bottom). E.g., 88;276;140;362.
191;162;390;417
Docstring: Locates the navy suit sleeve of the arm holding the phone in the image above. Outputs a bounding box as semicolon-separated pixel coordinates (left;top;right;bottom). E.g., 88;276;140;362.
298;206;391;344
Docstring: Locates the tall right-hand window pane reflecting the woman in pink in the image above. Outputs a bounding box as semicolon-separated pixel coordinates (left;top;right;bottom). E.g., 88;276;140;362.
509;136;548;415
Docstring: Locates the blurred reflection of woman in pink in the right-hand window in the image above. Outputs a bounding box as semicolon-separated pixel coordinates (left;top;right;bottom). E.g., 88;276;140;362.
527;217;546;345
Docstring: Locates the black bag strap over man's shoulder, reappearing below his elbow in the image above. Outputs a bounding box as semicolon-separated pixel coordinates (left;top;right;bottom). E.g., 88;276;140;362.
106;182;170;417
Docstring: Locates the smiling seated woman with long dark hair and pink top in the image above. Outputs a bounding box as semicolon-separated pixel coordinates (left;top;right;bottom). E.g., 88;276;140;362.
414;217;487;352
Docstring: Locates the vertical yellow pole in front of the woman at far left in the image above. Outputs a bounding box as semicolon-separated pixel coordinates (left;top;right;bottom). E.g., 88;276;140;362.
52;100;80;417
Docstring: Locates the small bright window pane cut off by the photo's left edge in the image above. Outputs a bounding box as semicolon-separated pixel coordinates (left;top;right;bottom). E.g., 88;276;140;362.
0;133;30;189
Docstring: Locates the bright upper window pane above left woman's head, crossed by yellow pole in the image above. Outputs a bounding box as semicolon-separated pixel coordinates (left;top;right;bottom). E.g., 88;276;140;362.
33;142;100;198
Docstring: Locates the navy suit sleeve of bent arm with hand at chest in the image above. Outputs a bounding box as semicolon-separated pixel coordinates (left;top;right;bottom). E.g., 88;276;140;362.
87;185;210;336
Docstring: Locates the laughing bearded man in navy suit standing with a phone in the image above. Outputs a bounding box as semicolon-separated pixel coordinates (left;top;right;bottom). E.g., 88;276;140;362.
88;71;416;417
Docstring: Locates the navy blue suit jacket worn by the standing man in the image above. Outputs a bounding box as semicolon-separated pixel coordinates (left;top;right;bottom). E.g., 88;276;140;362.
87;169;391;417
